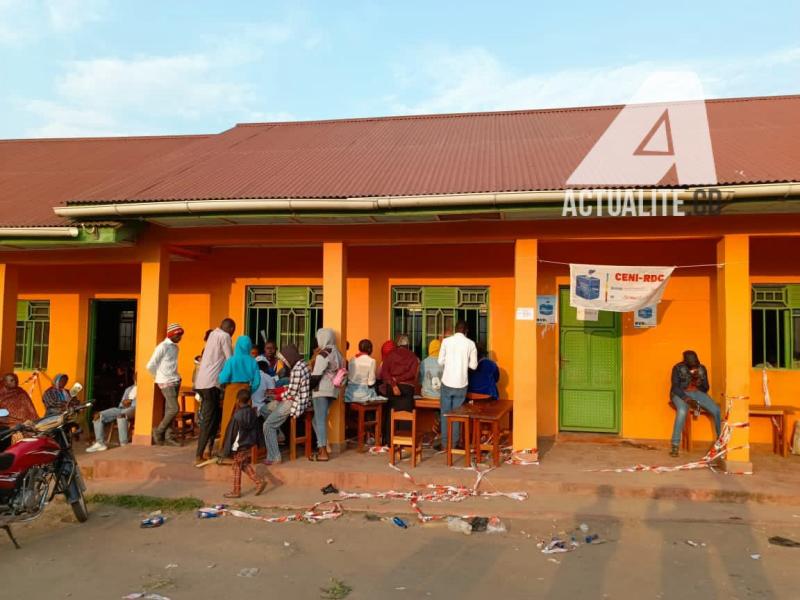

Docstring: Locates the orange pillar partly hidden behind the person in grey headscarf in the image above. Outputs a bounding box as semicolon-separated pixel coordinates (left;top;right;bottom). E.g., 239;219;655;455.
322;242;347;452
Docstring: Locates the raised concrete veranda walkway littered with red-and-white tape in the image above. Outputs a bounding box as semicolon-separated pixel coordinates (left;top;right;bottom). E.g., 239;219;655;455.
79;442;800;518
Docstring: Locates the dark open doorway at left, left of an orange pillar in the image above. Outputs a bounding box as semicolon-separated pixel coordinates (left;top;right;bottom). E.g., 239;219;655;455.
86;300;136;412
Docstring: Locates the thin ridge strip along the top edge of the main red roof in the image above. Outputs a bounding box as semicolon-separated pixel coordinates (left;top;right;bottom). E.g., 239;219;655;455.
236;94;800;127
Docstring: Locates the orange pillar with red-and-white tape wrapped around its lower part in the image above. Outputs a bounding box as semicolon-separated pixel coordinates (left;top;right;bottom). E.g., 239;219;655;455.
714;235;753;471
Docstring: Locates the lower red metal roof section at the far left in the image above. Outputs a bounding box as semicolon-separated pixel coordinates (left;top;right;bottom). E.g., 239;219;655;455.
0;135;207;227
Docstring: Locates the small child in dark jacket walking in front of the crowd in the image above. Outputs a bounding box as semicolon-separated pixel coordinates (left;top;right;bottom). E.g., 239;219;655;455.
224;388;267;498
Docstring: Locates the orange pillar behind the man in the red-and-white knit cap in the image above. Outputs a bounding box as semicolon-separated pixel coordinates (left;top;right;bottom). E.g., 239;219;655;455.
133;242;169;446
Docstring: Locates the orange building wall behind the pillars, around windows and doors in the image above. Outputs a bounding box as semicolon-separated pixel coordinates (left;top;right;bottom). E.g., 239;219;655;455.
9;240;800;443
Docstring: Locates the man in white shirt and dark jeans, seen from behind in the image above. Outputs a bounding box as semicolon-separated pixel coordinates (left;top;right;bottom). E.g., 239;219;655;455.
437;321;478;450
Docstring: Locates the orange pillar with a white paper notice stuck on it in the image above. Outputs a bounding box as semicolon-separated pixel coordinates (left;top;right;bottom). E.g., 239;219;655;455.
511;240;539;450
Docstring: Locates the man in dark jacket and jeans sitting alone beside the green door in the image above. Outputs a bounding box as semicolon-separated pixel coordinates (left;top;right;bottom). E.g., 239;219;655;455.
669;350;721;456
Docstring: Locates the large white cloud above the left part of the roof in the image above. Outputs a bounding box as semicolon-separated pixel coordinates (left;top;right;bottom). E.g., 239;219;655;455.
20;18;306;137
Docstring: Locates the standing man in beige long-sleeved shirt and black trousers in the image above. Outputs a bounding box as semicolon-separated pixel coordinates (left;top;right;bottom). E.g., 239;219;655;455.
194;318;236;464
